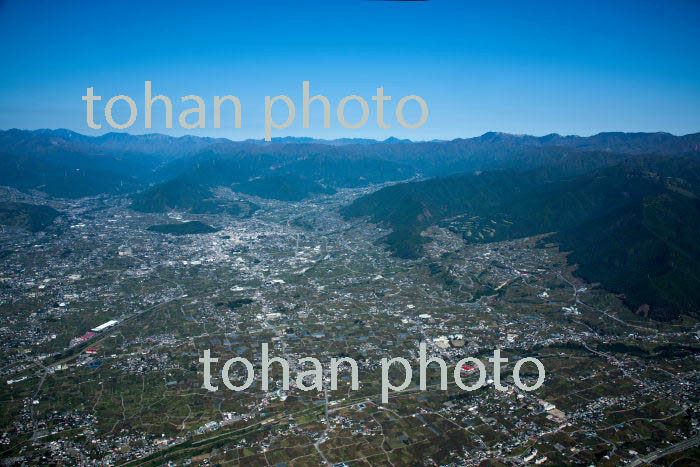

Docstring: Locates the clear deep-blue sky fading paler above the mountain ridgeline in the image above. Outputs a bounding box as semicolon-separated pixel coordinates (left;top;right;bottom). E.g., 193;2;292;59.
0;0;700;140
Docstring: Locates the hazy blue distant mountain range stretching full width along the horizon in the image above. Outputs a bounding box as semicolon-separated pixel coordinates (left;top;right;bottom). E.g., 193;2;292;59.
0;130;700;197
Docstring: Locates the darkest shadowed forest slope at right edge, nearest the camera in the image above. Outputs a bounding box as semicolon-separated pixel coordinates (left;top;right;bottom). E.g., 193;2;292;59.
554;192;700;320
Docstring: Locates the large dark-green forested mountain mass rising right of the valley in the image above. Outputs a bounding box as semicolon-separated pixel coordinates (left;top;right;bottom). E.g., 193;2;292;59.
343;156;700;319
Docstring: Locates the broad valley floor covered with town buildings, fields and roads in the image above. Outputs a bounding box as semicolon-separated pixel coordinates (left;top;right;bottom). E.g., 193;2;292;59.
0;189;700;466
